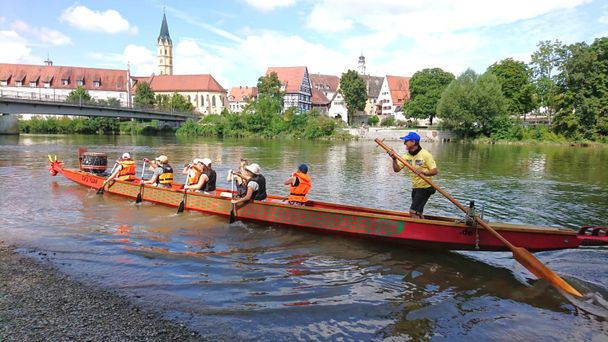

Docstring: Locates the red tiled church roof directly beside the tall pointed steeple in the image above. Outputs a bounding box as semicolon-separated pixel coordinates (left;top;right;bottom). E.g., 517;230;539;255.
143;74;226;93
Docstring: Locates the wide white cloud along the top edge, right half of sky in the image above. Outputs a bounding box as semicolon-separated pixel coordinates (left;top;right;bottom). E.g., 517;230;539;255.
309;0;591;37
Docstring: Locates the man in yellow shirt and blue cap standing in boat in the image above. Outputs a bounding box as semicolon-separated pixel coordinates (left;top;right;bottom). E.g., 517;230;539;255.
391;132;439;218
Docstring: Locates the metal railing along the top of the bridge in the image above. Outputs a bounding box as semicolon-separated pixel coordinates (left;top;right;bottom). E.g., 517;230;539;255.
0;88;196;117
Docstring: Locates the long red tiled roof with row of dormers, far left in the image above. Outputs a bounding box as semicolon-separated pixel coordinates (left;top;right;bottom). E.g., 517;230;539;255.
0;63;127;91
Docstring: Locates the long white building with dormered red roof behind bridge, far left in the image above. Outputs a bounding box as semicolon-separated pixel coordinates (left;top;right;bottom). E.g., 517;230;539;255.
0;60;130;106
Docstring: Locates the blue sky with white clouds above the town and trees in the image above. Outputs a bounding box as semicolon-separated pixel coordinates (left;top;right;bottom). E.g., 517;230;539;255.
0;0;608;88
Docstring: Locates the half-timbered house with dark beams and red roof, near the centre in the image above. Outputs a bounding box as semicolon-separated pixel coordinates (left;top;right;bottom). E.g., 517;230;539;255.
266;66;312;113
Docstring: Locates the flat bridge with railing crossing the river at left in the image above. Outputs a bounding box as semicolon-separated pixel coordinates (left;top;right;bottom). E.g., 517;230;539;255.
0;91;200;134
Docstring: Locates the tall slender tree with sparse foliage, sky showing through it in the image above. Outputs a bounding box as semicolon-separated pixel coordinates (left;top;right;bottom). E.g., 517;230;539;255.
531;40;566;122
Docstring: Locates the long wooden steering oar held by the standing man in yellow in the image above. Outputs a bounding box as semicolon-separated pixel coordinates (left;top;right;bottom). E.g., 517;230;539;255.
374;138;583;297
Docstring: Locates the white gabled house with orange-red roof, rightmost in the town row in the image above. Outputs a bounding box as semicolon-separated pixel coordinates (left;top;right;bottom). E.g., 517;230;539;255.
376;75;410;121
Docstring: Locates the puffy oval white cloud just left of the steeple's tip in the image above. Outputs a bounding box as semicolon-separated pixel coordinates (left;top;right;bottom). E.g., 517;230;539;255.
59;5;138;34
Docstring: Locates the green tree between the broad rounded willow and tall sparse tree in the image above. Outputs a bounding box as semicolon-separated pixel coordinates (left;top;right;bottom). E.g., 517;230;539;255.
488;58;534;117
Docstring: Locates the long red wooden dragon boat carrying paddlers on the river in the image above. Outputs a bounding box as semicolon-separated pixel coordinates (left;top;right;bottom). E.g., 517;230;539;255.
49;157;608;251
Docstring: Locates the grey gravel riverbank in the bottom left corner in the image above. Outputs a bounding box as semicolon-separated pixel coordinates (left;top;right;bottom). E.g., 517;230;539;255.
0;241;202;341
